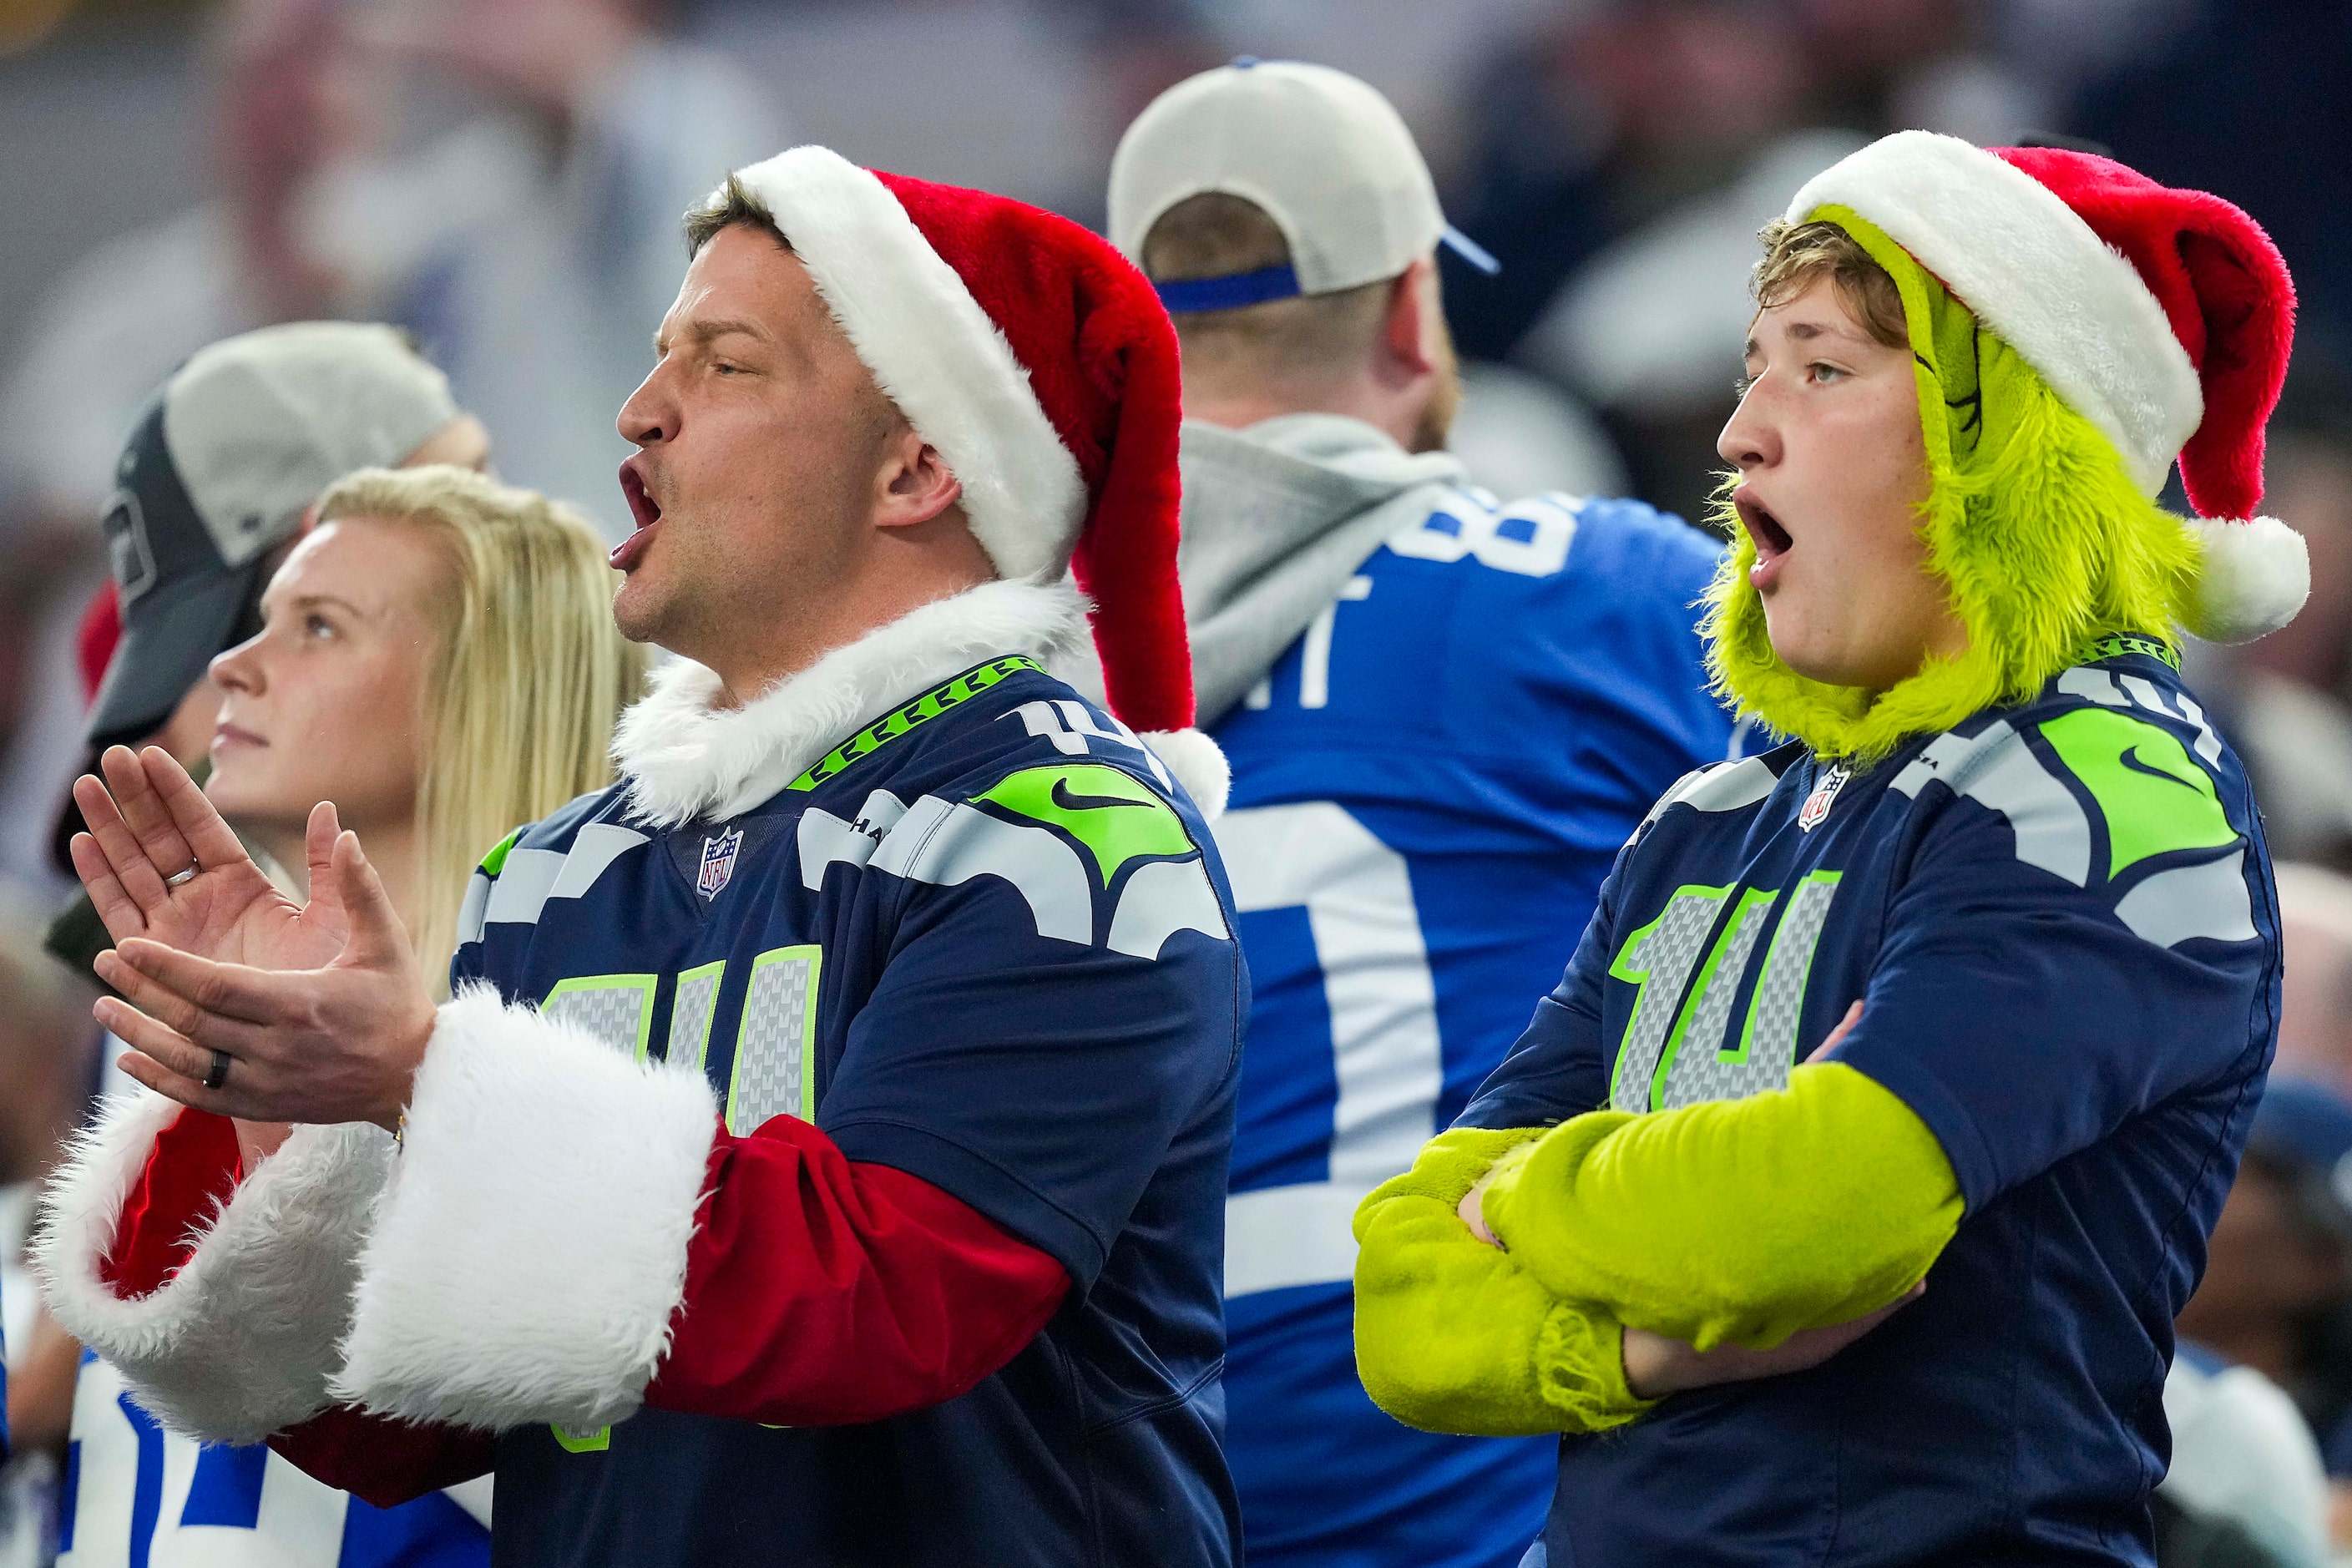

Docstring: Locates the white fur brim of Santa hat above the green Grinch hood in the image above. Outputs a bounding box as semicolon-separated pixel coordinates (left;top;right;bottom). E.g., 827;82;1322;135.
1788;132;2204;496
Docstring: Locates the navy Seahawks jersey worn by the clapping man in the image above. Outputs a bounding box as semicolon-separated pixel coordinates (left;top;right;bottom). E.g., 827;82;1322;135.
454;656;1249;1568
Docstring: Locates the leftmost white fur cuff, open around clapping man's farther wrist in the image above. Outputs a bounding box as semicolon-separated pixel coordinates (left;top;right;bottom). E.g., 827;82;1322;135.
33;1090;392;1444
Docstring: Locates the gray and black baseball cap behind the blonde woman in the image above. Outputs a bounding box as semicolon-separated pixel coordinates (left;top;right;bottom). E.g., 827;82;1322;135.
89;322;458;746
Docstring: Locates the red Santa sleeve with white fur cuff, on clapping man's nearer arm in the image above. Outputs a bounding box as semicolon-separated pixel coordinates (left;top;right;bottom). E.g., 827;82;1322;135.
334;989;1068;1429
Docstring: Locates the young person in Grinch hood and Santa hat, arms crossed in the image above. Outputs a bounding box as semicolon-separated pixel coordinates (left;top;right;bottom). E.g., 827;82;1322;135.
1357;132;2307;1568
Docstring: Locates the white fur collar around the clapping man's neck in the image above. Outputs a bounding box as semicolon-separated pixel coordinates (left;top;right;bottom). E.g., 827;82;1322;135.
611;580;1086;827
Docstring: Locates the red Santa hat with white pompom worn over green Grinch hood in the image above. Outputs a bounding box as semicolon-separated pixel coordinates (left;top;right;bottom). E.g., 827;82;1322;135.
1788;132;2312;642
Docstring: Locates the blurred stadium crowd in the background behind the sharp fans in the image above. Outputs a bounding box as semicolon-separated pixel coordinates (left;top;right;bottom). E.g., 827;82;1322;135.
0;0;2352;1563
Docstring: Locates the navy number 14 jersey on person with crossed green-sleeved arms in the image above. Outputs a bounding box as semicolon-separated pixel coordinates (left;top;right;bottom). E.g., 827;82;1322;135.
1463;637;2279;1568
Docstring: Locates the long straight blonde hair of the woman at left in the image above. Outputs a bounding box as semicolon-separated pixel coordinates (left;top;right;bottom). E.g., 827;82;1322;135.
317;465;645;988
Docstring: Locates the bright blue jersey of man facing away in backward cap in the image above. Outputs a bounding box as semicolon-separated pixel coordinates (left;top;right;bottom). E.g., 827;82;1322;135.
1216;493;1731;1568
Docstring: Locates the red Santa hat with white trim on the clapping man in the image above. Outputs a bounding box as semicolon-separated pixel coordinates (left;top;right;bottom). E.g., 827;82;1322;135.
736;146;1226;811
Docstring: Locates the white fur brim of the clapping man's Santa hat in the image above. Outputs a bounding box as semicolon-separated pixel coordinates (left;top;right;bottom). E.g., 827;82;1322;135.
736;146;1086;579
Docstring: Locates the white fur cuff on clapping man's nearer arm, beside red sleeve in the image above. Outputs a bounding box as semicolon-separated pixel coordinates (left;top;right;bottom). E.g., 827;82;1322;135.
334;988;717;1429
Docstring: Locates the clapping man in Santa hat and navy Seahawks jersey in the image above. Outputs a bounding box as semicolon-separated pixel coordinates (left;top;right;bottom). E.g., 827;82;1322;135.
40;148;1249;1565
